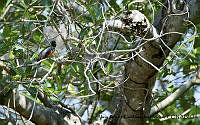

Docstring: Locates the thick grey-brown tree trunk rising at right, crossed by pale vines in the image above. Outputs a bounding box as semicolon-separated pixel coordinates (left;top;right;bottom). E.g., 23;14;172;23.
110;0;200;125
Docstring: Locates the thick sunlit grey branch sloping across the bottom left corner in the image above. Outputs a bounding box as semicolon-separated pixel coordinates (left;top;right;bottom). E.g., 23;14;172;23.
0;91;81;125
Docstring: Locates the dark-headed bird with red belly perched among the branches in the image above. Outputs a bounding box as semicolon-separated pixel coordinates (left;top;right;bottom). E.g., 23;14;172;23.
37;41;56;61
